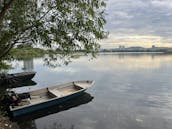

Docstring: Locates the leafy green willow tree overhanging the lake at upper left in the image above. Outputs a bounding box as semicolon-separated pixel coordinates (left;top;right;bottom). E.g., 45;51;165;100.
0;0;106;61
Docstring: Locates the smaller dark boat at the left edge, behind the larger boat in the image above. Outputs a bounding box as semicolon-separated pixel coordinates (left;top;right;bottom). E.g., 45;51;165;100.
0;72;36;85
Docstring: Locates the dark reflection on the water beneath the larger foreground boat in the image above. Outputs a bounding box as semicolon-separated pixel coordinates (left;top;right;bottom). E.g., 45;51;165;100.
13;92;94;122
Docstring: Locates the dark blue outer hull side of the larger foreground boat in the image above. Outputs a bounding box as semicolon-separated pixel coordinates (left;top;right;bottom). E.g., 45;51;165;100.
11;90;85;117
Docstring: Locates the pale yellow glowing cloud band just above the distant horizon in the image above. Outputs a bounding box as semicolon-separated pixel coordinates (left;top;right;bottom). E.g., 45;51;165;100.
100;33;172;48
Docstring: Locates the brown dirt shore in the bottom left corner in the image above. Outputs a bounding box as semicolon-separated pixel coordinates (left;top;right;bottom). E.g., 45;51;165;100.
0;115;19;129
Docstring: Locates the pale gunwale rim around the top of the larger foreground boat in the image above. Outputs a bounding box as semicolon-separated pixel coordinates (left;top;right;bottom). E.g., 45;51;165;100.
9;80;94;112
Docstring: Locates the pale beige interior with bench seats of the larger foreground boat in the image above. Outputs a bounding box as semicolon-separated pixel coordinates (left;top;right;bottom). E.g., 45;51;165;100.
12;83;83;109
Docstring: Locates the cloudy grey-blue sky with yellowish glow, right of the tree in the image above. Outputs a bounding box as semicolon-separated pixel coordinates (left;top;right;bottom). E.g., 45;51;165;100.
100;0;172;48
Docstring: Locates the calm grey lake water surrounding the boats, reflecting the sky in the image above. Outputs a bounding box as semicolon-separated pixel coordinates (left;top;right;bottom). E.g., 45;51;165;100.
9;54;172;129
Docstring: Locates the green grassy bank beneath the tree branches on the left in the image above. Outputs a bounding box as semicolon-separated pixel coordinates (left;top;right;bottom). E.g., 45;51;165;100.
11;47;47;60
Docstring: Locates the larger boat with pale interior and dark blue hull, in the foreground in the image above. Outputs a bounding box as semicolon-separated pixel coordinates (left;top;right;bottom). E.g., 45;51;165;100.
9;80;94;117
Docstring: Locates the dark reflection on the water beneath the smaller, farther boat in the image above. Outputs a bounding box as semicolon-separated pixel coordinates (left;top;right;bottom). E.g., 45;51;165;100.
2;80;37;88
